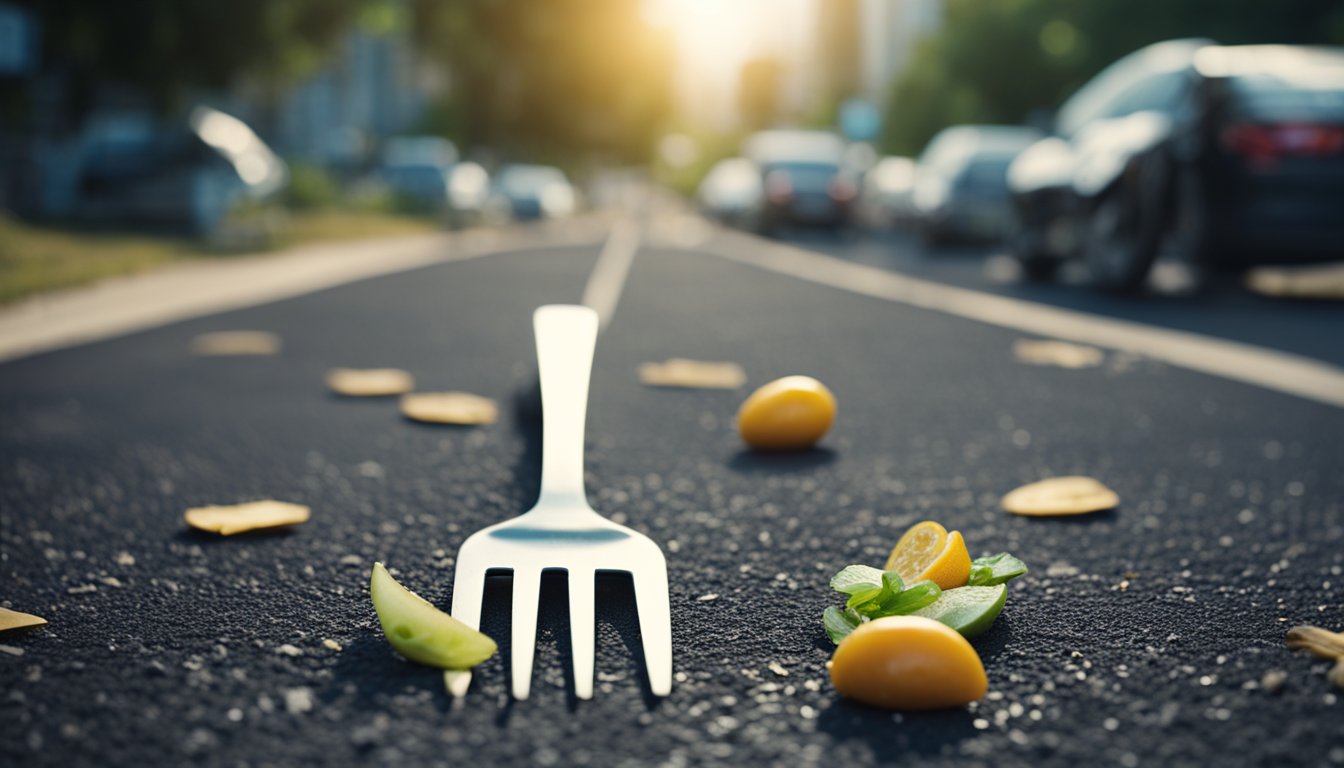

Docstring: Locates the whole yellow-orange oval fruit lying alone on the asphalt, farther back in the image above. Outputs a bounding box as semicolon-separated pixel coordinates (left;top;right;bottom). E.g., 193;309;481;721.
738;377;836;451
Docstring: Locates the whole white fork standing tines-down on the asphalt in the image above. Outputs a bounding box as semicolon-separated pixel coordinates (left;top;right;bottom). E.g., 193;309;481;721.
452;304;672;699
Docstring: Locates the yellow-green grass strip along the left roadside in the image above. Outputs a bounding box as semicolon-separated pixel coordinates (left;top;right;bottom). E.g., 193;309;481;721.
0;208;439;304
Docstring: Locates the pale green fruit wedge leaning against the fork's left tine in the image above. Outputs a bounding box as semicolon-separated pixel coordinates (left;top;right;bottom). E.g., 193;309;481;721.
368;562;496;670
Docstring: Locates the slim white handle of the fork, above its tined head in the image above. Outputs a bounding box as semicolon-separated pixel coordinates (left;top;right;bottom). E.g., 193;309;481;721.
532;304;598;507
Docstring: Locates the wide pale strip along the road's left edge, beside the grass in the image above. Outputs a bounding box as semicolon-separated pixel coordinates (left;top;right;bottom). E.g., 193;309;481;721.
0;226;605;362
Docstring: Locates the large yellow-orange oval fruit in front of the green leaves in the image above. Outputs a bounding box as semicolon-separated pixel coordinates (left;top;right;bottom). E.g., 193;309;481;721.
829;616;989;710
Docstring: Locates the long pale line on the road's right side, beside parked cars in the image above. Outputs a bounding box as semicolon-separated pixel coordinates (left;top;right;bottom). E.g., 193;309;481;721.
700;233;1344;408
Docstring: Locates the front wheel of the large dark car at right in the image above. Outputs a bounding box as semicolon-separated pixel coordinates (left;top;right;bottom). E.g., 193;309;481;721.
1083;187;1160;292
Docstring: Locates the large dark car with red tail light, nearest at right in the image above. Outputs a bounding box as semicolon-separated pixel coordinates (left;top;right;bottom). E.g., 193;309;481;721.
1009;39;1344;291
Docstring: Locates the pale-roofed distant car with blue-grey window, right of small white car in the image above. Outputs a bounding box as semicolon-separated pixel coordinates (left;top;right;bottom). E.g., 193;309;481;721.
745;130;859;231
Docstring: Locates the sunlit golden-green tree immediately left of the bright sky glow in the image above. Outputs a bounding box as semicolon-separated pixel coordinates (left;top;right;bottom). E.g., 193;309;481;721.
414;0;672;160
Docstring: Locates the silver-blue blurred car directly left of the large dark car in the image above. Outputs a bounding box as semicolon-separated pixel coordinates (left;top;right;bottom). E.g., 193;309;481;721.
911;125;1042;245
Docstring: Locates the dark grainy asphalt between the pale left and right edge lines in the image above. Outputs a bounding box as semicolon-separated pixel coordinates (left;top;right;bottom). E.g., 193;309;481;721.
0;216;1344;768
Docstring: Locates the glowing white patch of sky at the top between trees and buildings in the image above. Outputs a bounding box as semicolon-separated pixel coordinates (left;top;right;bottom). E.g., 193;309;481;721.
646;0;814;127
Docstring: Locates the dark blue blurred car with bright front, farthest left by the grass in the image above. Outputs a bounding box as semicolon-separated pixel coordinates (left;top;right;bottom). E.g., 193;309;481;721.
71;106;289;234
